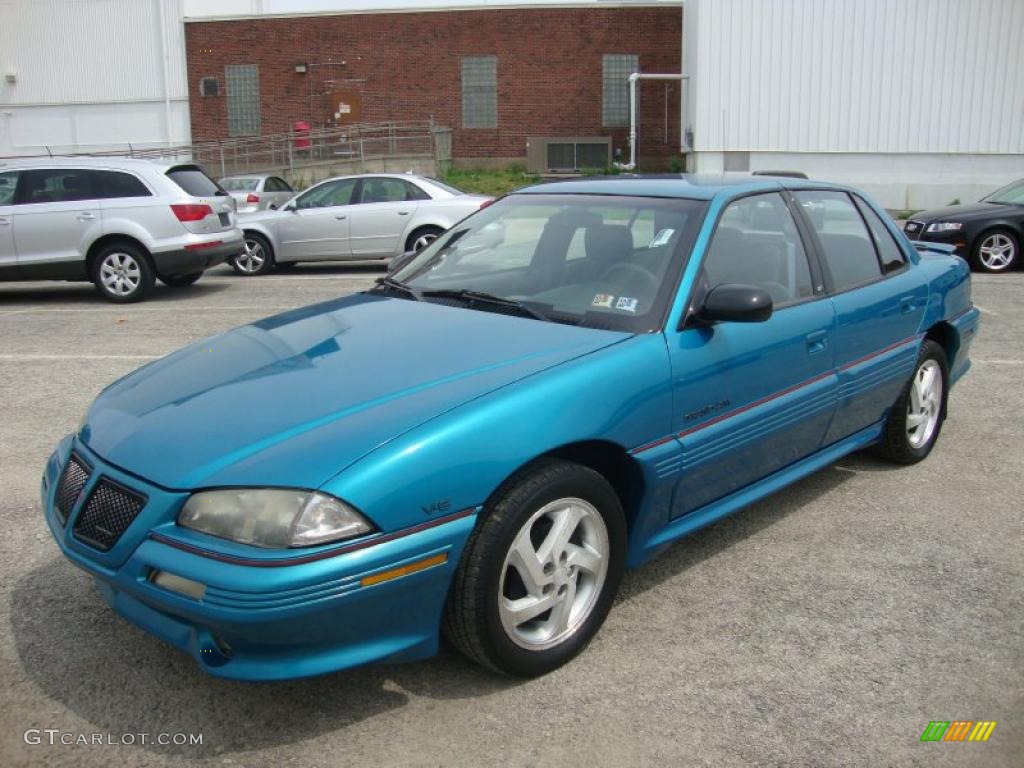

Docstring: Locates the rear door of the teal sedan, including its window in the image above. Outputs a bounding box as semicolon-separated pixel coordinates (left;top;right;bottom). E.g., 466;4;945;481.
793;189;928;442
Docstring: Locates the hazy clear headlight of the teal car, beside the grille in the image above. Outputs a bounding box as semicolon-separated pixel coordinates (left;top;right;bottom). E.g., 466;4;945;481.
178;488;373;547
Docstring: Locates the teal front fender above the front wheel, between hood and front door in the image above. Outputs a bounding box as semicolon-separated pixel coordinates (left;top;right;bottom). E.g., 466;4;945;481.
322;334;672;530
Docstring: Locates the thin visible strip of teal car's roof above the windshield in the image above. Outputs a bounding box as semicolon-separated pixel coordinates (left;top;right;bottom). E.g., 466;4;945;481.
514;173;847;200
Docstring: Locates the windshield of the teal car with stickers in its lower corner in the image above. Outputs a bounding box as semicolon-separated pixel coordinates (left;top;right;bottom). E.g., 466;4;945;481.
391;195;706;332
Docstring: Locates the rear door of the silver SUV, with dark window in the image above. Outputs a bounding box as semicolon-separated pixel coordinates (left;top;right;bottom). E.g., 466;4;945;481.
11;168;101;274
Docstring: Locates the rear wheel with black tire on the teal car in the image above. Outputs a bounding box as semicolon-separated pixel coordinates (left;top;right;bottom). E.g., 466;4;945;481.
878;339;949;464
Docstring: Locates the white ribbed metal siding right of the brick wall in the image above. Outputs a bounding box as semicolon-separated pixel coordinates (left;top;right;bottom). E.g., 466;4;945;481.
683;0;1024;154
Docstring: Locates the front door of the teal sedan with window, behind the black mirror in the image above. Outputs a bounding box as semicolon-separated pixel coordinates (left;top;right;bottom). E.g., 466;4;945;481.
669;193;836;517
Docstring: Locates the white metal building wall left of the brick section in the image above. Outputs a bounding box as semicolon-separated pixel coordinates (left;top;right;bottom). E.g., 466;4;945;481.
0;0;190;155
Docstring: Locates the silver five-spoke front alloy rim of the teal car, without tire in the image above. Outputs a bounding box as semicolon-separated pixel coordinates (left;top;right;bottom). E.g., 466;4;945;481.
498;498;610;650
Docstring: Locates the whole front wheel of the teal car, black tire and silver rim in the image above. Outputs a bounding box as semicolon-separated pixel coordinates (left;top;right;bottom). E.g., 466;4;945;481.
443;459;626;677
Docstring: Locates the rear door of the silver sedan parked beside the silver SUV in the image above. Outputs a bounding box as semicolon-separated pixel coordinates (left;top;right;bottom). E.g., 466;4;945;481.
344;176;429;258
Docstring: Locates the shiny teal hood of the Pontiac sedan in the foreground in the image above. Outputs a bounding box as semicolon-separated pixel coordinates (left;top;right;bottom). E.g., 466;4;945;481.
79;294;629;489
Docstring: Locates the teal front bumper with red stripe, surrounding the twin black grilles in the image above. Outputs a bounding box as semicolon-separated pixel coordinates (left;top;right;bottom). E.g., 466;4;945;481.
42;437;476;680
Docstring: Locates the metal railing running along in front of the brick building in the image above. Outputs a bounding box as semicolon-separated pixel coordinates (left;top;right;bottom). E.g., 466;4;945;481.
3;121;452;176
